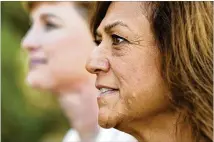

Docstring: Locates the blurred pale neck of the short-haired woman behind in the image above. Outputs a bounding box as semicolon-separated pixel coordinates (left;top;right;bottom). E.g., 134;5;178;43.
58;79;99;142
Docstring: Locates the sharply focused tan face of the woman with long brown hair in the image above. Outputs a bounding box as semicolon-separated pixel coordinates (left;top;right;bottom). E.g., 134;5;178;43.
86;2;169;127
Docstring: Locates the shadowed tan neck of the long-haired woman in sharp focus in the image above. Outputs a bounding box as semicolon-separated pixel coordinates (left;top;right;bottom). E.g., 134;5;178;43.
118;111;192;142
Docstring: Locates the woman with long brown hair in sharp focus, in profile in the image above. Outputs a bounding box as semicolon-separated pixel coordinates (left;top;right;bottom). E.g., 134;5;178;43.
86;2;213;142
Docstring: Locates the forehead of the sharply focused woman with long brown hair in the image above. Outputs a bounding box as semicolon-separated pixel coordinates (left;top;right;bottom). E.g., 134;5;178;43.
97;2;150;33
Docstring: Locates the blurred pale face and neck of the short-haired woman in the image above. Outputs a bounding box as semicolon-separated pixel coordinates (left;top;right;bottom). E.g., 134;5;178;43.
22;2;98;142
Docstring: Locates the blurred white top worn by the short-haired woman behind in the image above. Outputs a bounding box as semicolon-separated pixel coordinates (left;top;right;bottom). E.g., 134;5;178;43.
63;128;137;142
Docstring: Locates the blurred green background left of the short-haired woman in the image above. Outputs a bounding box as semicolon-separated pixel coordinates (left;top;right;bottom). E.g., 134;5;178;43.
1;1;69;142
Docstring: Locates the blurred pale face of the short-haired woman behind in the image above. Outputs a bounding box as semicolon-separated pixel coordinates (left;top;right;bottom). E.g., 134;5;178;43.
22;2;93;90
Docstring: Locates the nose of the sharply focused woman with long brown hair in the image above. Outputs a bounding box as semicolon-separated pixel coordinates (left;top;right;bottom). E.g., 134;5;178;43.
86;48;110;74
